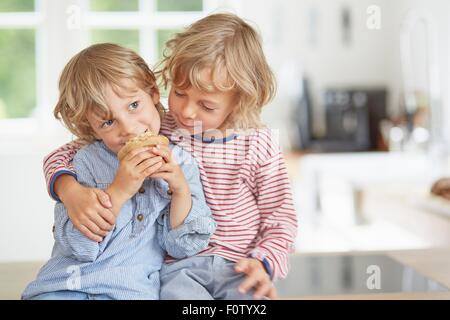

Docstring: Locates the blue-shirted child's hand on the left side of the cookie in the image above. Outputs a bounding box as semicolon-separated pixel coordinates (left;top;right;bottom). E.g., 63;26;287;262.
108;147;163;201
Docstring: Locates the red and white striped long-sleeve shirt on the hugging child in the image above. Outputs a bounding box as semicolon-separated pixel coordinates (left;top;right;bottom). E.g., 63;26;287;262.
44;113;297;279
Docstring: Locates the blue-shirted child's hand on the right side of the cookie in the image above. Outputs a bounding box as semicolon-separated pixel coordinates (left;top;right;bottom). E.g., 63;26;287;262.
151;145;189;194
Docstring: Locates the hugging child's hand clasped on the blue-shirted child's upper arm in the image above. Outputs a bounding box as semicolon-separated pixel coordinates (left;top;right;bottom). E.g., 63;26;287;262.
61;182;116;242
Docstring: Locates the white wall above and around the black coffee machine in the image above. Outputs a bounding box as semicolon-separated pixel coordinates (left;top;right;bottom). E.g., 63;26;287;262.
239;0;450;147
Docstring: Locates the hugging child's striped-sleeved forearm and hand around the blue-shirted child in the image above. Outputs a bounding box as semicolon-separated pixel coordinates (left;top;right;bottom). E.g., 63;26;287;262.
44;141;115;242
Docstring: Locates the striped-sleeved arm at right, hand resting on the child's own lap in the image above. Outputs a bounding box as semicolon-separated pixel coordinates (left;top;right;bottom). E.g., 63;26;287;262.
236;141;297;298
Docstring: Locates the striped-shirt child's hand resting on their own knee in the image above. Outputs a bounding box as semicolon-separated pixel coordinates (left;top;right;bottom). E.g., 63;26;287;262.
234;258;277;300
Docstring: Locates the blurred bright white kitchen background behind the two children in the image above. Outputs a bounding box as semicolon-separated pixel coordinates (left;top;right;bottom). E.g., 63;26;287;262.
0;0;450;262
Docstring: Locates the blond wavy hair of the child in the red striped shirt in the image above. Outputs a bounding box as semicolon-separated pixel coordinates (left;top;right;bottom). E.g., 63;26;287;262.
156;13;276;129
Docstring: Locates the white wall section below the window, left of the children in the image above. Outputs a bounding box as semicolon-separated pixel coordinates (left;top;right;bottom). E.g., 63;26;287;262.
0;135;72;262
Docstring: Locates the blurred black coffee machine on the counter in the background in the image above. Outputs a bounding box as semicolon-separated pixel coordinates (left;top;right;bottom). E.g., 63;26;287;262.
294;80;387;152
